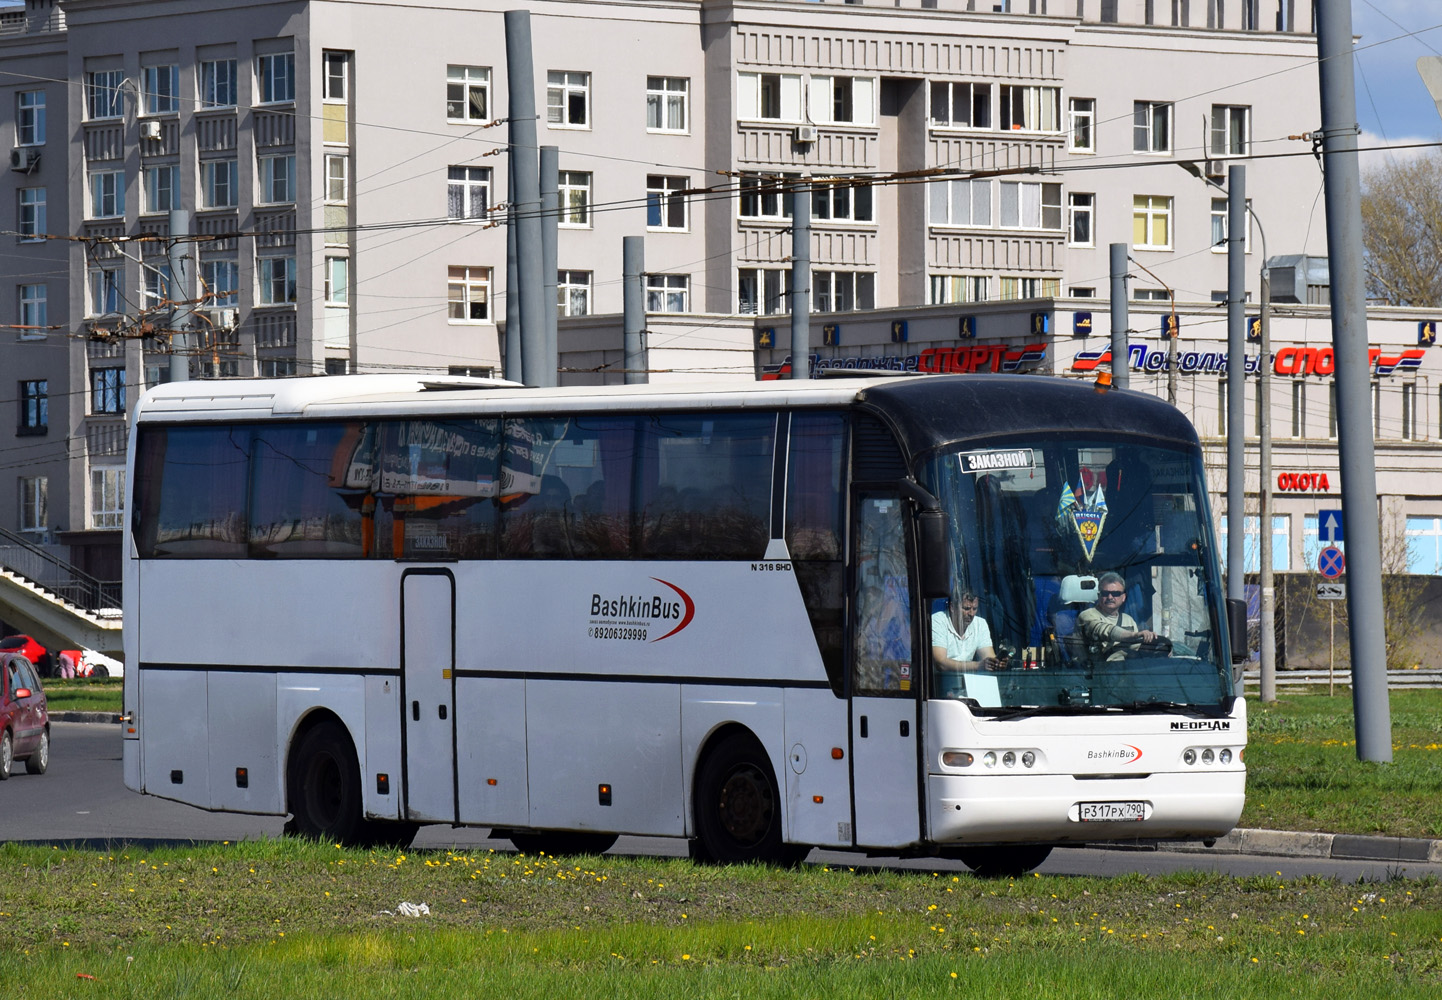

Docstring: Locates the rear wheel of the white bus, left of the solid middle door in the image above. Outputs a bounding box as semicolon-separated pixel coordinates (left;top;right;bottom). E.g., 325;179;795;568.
286;719;366;846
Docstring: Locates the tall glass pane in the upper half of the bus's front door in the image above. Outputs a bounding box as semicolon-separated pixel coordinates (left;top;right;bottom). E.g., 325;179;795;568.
851;492;911;696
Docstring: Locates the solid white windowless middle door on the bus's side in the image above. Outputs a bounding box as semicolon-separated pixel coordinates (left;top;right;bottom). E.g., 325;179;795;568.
401;569;456;823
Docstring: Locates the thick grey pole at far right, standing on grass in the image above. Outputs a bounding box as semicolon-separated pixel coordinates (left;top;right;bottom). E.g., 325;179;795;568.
1317;0;1392;763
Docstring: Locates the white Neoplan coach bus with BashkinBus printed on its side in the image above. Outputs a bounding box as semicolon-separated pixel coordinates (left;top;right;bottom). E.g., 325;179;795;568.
124;375;1246;873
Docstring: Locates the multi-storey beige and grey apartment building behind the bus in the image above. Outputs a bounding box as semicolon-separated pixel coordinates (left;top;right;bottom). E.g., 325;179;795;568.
0;0;1325;577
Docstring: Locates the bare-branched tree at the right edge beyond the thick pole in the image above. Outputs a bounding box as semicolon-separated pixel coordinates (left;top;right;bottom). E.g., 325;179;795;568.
1361;152;1442;306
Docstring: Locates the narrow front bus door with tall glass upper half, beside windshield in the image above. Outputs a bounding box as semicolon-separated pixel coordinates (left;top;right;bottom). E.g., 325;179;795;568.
849;491;921;847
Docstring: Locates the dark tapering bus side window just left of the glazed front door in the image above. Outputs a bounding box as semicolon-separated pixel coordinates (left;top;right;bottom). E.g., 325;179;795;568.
786;411;846;696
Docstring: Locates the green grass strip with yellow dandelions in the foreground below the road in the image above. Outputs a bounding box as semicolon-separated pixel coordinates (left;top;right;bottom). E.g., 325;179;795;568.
0;841;1442;1000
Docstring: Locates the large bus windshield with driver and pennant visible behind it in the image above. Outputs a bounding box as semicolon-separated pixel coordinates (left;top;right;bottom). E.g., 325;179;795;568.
924;436;1233;716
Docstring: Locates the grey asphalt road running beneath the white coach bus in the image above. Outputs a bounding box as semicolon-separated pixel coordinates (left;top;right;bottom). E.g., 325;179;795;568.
11;723;1442;882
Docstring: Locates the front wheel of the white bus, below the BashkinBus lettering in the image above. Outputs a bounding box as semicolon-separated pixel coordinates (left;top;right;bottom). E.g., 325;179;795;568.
691;733;809;866
